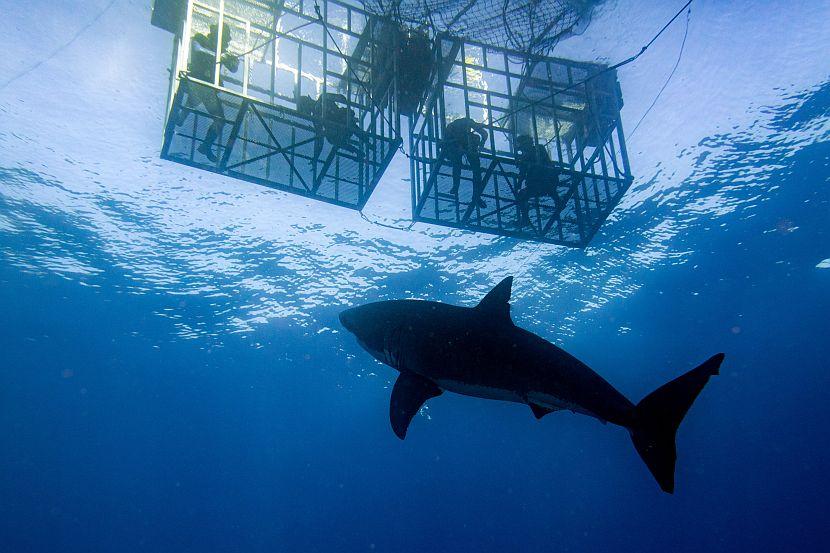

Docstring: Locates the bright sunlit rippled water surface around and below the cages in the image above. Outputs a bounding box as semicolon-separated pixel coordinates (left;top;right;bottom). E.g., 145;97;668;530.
0;2;830;338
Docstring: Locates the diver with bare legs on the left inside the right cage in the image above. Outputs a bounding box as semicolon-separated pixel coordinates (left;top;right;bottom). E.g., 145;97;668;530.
438;117;487;207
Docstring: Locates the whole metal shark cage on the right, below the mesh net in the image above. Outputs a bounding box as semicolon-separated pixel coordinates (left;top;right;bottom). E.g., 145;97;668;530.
410;36;632;247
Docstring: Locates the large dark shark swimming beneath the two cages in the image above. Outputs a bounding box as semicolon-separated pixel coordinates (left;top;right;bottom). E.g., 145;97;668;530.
340;277;724;493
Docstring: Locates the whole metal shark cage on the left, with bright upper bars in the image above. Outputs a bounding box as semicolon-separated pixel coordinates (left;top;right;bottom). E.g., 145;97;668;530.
153;0;400;209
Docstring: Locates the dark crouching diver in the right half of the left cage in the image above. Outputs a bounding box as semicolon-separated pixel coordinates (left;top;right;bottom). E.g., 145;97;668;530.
297;93;364;165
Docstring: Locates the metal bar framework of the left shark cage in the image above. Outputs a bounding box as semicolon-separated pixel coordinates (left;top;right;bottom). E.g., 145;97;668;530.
154;0;402;210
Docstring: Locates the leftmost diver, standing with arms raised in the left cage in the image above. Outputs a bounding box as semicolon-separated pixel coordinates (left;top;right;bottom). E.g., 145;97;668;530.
176;24;239;163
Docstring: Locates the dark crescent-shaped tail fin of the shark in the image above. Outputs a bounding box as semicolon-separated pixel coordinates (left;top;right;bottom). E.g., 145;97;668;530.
630;353;724;493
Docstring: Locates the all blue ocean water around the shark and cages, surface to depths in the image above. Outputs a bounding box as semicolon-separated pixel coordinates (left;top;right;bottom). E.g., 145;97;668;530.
0;0;830;553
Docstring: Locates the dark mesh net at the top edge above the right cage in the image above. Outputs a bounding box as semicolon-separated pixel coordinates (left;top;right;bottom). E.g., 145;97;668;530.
363;0;601;54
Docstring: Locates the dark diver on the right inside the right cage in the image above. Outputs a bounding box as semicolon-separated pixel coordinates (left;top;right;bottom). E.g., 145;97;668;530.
516;134;562;228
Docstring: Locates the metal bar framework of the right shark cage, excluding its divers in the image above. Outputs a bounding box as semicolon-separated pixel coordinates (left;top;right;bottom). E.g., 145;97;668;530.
409;34;633;247
